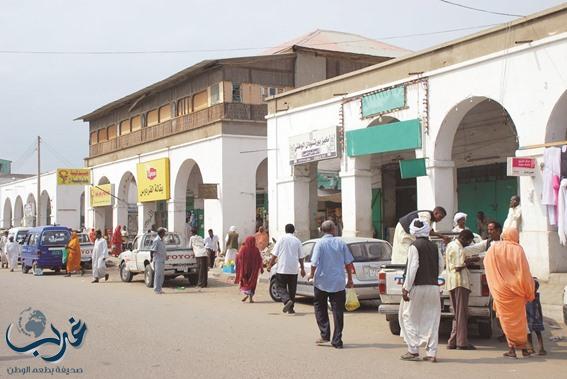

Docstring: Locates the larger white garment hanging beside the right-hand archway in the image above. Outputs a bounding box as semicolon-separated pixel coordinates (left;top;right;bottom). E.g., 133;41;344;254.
541;147;561;225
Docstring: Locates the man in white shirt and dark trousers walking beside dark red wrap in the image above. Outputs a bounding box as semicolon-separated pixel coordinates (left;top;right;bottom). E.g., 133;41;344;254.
268;224;305;314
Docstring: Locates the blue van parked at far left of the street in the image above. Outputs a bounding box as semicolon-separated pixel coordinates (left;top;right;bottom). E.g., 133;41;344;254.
22;226;71;274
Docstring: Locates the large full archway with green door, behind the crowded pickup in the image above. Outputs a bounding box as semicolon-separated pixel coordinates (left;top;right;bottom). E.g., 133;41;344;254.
438;96;518;232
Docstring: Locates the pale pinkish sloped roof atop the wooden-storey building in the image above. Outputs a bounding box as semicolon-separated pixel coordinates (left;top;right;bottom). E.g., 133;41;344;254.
264;29;411;58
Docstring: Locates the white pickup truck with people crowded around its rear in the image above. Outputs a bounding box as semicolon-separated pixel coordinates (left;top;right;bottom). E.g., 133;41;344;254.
378;240;495;338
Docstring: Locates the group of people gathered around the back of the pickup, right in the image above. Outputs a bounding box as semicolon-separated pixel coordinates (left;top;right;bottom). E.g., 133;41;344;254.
394;200;546;362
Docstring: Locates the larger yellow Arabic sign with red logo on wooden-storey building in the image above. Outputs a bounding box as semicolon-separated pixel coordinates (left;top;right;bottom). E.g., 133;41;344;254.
137;158;169;203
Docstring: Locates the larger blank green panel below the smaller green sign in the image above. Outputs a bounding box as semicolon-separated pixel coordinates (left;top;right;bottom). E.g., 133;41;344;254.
346;118;421;157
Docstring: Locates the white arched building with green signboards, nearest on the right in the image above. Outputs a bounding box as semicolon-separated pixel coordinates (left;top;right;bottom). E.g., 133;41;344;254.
268;5;567;279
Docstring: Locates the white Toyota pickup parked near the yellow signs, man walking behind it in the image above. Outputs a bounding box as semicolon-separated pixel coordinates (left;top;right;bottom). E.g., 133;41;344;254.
118;233;198;287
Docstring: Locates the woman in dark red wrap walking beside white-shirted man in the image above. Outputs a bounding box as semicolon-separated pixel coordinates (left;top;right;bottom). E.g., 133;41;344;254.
234;236;264;303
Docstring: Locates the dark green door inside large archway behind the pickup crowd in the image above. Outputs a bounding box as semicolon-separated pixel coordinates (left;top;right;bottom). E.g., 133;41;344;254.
458;178;518;233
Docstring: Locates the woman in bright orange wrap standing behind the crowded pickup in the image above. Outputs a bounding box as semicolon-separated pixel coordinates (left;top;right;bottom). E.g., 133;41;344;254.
484;228;535;358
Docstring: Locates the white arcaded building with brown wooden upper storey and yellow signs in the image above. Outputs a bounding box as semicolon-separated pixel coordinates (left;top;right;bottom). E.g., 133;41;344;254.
80;31;406;240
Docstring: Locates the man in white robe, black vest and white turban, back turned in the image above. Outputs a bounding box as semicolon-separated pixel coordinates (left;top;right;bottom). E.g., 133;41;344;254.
398;219;444;362
